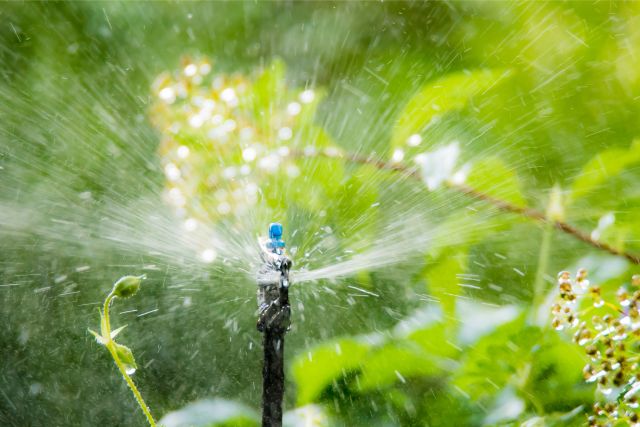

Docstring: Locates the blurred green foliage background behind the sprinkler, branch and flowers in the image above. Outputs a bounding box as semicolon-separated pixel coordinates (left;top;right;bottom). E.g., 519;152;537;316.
0;2;640;426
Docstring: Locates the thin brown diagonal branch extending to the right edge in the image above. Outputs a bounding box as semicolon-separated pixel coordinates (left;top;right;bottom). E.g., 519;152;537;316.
292;150;640;265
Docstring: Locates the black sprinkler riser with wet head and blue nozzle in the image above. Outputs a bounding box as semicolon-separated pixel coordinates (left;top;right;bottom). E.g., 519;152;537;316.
257;222;291;427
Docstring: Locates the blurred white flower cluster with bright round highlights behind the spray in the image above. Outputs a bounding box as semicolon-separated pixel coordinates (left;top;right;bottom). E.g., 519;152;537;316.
151;59;317;227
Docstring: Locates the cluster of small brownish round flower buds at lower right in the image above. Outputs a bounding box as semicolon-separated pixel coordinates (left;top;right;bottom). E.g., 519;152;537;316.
552;269;640;426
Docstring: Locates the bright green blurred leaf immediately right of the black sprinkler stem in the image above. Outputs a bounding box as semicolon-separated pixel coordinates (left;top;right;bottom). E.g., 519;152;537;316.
292;338;371;405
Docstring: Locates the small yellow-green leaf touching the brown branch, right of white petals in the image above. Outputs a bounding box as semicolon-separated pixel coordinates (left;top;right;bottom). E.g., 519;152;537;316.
466;157;525;206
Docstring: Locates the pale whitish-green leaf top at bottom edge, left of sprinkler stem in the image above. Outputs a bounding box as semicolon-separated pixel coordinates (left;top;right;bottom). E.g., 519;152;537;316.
158;398;260;427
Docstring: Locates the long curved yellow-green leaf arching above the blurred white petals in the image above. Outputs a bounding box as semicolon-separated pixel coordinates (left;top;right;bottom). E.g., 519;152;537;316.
391;69;510;148
